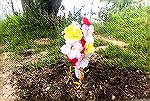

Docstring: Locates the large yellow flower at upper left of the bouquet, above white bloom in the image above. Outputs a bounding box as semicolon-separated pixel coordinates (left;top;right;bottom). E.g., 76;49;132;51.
64;25;83;41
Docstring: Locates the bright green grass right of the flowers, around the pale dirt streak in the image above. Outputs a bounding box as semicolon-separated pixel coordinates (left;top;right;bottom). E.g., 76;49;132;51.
95;7;150;71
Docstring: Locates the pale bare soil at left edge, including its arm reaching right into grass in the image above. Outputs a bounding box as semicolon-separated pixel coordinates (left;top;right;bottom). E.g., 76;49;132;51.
0;50;48;101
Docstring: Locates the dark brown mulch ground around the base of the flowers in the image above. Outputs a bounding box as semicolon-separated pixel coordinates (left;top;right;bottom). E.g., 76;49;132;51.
11;61;150;101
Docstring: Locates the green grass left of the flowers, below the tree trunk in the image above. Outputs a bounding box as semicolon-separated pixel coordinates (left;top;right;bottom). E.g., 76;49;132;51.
0;12;65;68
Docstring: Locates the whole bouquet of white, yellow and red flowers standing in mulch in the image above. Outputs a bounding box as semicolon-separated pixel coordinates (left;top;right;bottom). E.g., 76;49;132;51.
61;17;95;79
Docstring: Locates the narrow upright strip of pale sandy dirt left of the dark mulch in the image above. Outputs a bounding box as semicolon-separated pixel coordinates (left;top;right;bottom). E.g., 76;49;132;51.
0;52;16;101
